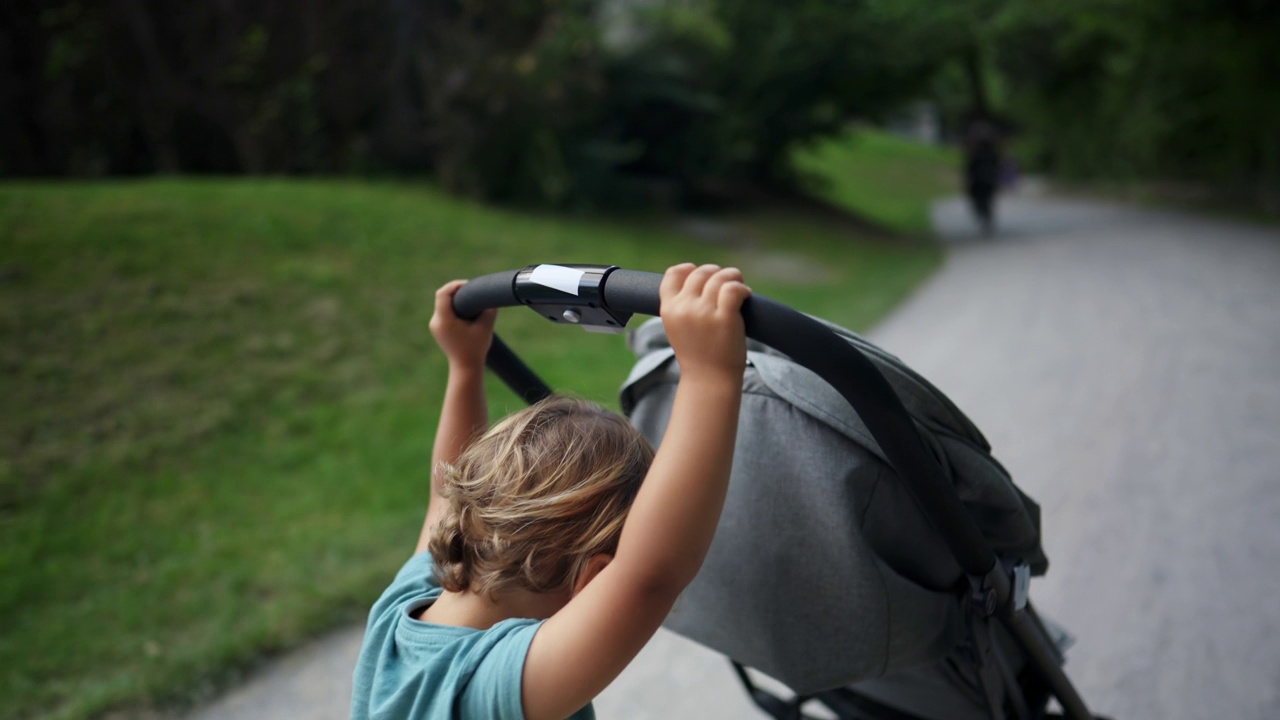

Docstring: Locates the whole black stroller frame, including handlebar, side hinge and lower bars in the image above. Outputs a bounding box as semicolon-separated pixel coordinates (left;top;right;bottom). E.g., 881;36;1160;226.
453;265;1094;720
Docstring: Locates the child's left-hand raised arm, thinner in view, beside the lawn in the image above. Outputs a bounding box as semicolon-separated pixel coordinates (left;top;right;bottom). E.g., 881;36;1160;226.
415;281;498;552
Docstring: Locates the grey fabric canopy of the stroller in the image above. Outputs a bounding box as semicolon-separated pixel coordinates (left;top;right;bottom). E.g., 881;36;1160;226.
621;319;1047;693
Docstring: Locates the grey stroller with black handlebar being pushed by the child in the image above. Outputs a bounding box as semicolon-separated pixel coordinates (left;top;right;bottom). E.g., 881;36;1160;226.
454;265;1093;720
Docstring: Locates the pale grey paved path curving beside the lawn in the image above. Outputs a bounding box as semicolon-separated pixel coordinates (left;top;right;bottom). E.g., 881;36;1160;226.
192;190;1280;720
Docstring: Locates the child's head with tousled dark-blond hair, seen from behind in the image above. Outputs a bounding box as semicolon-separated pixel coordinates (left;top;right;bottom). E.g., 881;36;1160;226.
430;397;653;597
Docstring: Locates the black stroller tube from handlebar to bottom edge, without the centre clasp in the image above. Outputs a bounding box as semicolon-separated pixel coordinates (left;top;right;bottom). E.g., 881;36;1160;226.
453;265;1093;720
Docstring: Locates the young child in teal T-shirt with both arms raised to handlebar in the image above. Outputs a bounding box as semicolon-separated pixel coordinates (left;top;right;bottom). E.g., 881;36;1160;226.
351;264;751;720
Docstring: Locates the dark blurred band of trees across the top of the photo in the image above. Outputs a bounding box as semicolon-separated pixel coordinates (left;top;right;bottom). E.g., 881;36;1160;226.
0;0;1280;208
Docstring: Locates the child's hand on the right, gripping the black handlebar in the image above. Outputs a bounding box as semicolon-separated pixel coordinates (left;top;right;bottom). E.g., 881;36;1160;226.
658;263;751;382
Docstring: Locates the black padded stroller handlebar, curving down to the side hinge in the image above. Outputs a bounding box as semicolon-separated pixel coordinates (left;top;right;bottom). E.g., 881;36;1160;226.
453;266;1004;576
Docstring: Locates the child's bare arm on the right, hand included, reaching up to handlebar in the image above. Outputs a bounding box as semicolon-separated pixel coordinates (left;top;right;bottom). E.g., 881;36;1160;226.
521;264;751;720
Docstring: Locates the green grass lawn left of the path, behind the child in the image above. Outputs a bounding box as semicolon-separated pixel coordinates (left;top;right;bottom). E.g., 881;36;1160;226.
0;130;941;719
